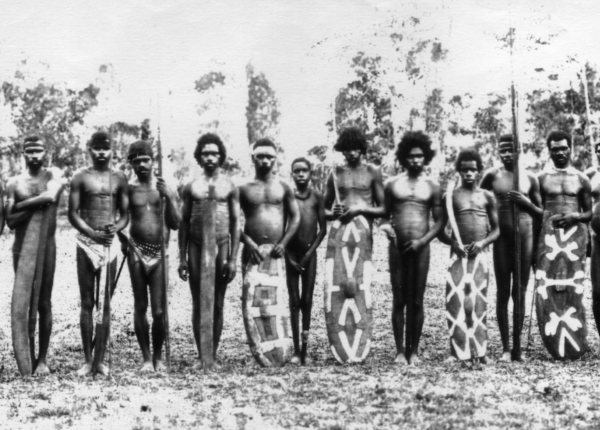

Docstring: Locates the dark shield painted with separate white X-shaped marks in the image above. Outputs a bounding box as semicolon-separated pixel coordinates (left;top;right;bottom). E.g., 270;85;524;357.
535;216;588;360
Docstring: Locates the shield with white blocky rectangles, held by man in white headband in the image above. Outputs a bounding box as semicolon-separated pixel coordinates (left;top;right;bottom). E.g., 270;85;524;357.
242;245;293;367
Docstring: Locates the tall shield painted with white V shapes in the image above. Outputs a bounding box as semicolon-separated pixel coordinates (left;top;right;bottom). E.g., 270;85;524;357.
324;216;373;363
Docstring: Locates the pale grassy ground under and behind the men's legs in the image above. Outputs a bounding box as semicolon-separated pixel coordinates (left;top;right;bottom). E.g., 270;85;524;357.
0;220;600;429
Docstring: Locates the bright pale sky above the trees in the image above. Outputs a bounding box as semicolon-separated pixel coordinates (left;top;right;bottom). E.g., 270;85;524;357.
0;0;600;174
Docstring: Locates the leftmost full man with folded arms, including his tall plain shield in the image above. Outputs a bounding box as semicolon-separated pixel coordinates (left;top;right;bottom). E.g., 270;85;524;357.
2;136;63;375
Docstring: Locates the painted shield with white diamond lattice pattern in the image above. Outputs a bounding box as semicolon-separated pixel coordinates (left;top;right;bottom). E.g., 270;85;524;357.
446;252;489;360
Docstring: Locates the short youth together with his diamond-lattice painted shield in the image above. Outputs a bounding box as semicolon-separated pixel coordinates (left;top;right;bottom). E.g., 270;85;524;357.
438;149;500;364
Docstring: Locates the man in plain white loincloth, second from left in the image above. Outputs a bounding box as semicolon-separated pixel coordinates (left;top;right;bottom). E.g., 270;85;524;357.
69;131;129;376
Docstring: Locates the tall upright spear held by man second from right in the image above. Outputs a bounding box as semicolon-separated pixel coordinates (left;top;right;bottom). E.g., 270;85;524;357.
510;29;522;361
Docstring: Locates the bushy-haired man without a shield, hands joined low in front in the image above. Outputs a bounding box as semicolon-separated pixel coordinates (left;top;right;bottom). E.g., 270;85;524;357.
385;131;443;365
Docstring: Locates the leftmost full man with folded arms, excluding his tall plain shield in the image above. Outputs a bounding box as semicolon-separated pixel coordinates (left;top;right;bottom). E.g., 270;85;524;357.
2;136;63;375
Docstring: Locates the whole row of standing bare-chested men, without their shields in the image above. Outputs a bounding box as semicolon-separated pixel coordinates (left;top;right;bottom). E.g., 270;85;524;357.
0;127;600;376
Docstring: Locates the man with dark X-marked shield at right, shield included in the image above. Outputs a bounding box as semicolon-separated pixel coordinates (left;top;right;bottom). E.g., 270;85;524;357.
536;131;592;359
